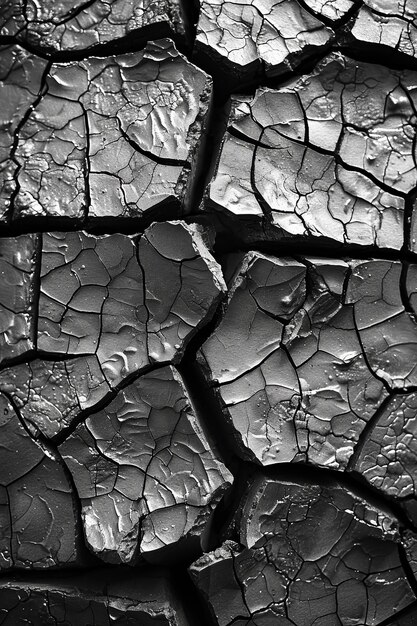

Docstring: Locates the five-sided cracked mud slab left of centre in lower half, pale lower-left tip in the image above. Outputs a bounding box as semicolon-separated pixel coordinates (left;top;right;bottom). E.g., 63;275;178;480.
59;367;232;563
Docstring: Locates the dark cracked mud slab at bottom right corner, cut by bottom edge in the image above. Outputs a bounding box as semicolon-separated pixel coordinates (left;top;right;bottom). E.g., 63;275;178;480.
190;478;413;626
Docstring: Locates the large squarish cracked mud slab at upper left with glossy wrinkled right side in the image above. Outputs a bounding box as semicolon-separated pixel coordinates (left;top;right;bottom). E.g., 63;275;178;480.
0;39;211;222
